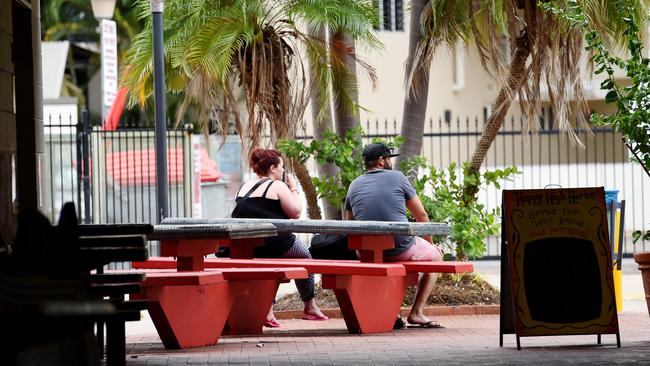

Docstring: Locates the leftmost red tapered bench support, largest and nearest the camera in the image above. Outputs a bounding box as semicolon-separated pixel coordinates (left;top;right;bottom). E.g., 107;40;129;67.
143;282;232;349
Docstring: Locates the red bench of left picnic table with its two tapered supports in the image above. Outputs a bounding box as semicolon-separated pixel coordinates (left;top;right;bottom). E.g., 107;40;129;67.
132;262;308;349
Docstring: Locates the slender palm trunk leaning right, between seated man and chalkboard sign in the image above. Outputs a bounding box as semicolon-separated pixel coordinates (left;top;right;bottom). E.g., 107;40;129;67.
464;30;530;202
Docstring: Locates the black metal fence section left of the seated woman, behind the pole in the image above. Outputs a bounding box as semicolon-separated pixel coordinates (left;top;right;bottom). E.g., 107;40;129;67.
42;114;192;223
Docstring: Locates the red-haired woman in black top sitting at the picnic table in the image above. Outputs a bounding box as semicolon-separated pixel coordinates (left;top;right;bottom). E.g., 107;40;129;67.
231;148;328;328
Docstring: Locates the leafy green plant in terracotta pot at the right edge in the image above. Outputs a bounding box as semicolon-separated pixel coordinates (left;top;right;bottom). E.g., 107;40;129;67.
542;0;650;313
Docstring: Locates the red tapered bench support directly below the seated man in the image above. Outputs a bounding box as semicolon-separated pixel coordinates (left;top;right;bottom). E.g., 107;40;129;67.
323;275;408;333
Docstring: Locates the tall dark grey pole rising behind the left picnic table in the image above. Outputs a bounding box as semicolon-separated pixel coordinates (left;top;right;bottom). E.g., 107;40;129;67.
151;0;169;224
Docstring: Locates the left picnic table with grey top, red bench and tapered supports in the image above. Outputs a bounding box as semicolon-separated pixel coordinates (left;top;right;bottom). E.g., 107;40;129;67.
133;223;308;349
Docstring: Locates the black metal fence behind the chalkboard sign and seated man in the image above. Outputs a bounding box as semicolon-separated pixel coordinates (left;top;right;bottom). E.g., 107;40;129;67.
301;117;650;257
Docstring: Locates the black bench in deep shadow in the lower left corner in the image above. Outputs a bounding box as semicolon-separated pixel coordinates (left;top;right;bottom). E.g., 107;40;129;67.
0;204;148;365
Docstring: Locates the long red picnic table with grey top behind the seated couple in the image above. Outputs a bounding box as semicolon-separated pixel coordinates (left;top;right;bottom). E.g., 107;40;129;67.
134;218;473;333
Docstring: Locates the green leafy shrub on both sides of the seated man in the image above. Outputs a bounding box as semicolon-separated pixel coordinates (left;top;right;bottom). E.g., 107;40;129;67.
278;127;519;260
